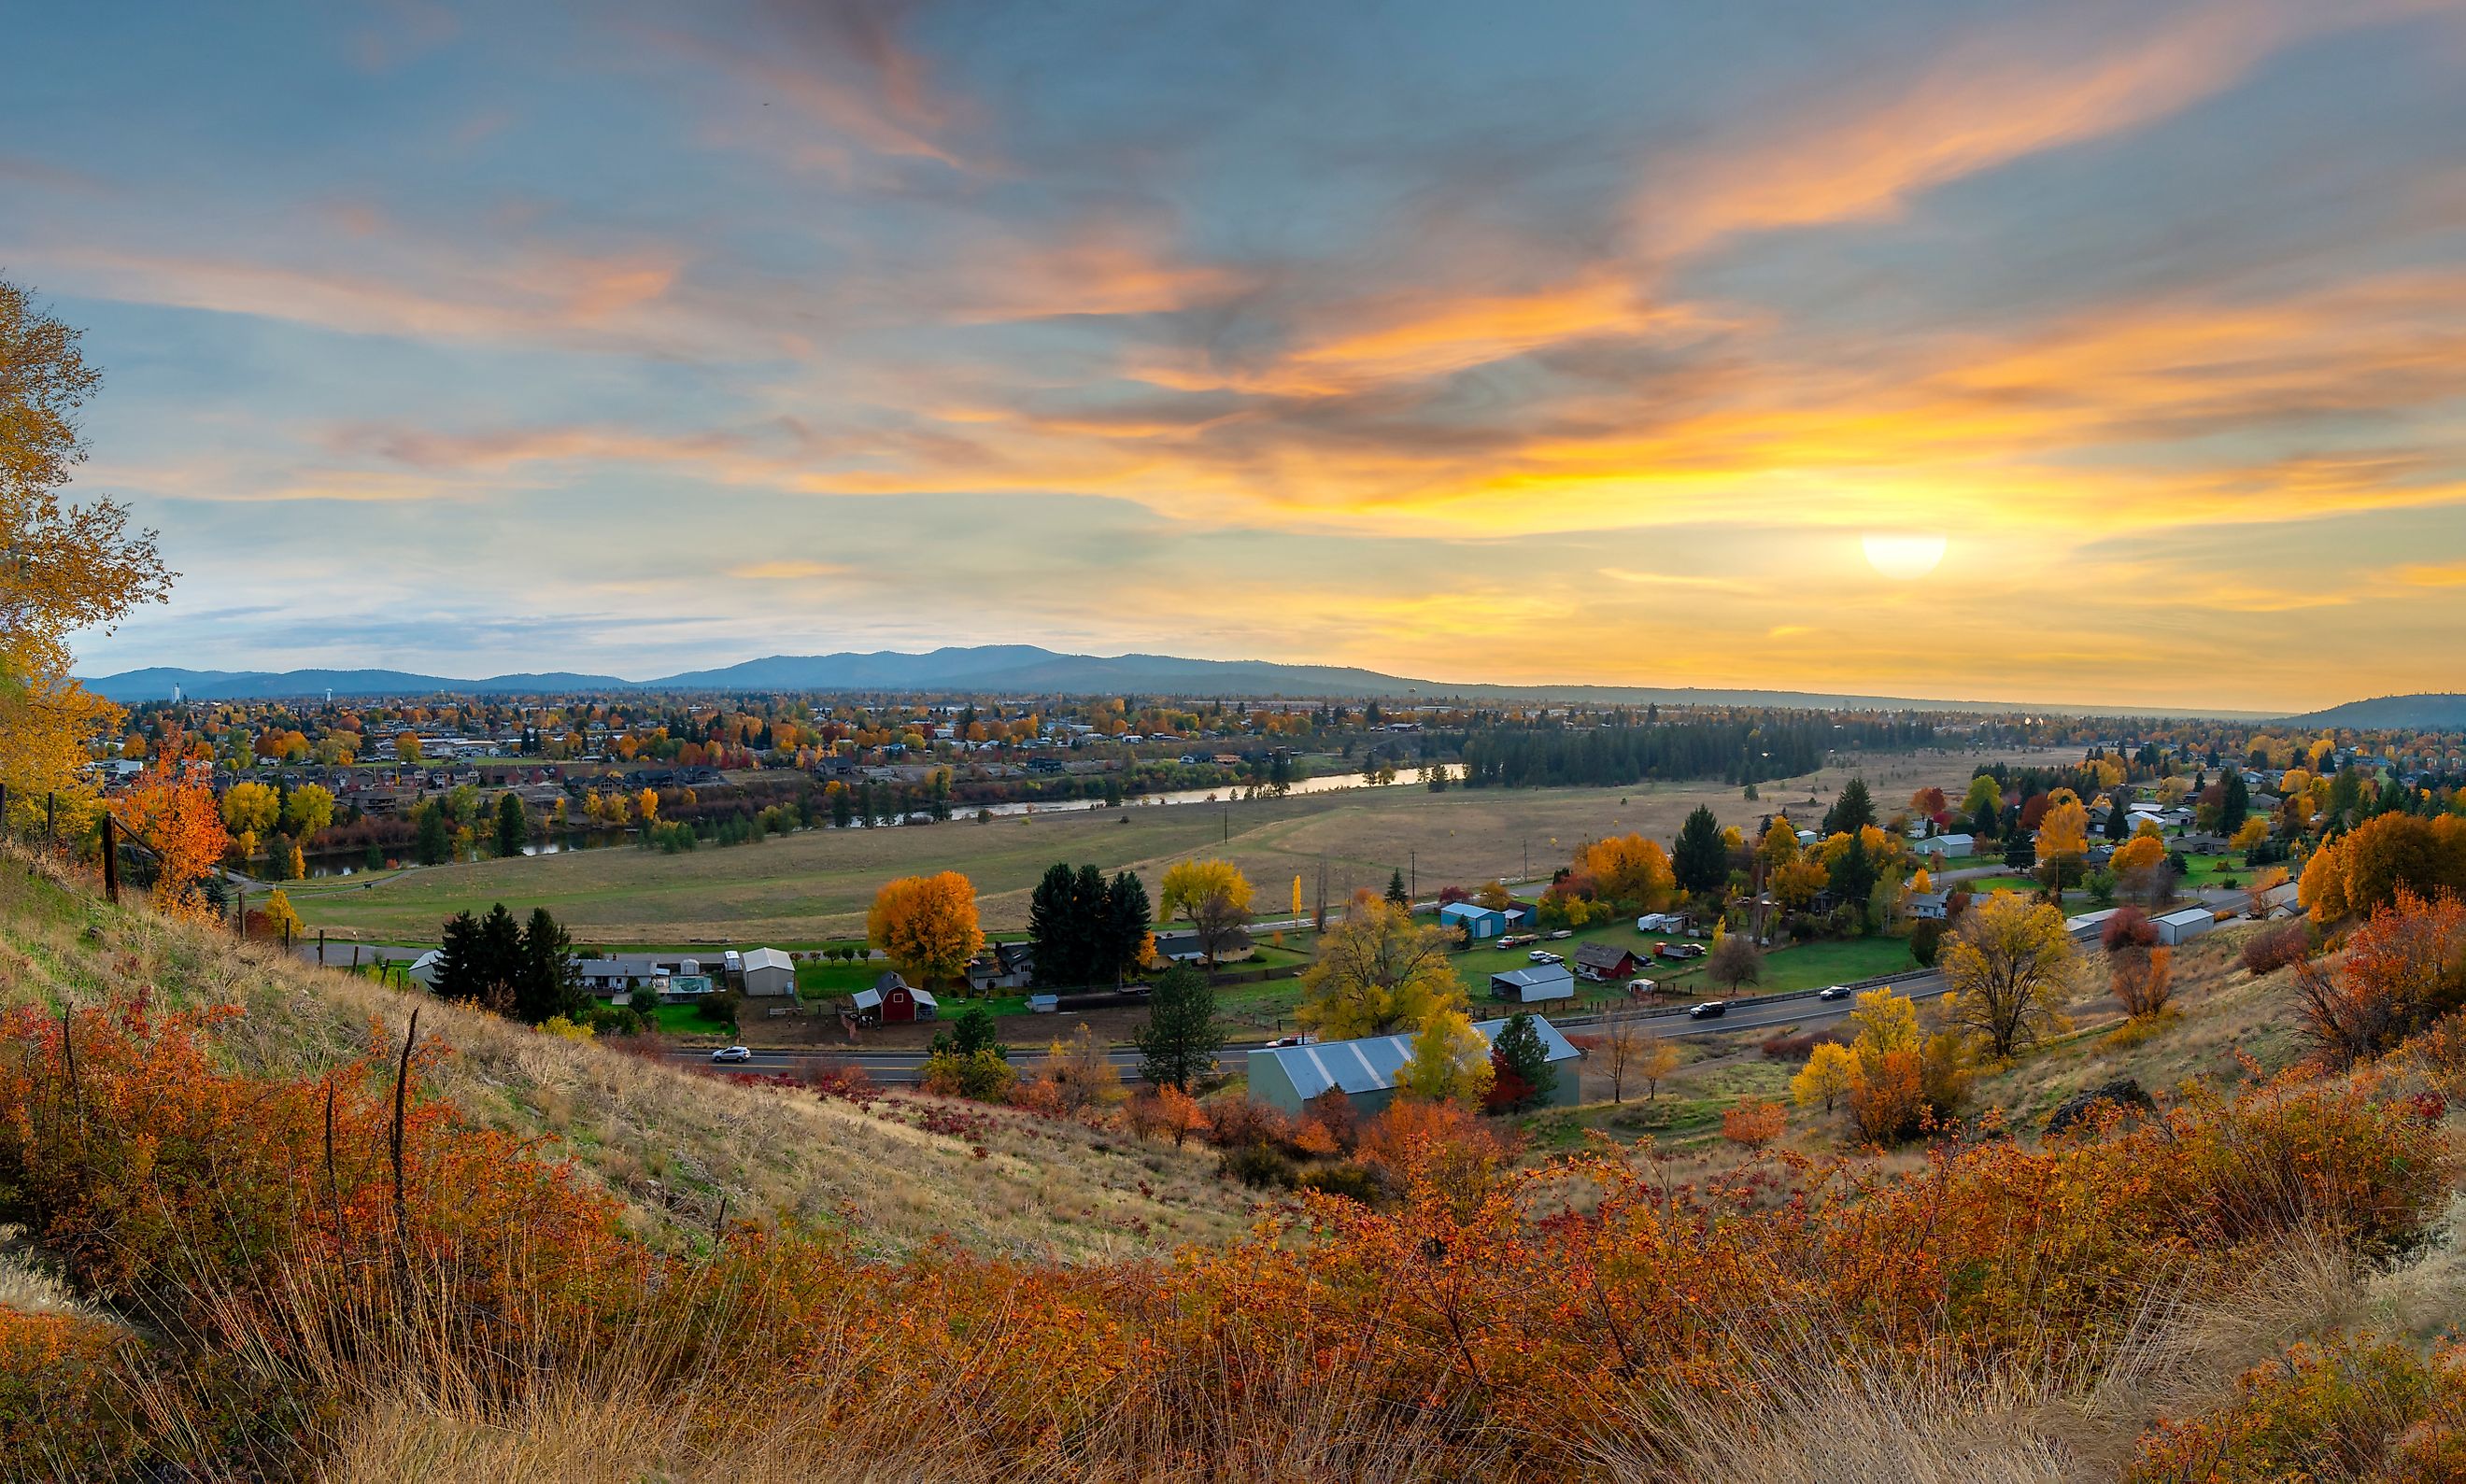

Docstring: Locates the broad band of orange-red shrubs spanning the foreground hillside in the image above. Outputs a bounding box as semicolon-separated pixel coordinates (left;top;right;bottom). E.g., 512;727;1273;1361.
0;981;2446;1477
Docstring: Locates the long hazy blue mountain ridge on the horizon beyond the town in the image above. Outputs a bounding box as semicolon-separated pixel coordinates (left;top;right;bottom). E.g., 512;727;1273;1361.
86;643;2264;717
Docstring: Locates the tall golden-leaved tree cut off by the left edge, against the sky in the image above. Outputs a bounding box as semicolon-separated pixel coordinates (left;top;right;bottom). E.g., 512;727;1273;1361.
0;278;173;821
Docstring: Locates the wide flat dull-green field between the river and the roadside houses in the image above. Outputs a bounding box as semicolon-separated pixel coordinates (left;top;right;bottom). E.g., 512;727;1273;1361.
291;752;2051;944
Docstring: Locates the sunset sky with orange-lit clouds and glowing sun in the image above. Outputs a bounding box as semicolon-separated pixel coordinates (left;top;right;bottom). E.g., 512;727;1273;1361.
14;0;2466;710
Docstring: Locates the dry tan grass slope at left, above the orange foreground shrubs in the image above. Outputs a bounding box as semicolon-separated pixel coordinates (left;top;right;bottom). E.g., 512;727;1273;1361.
0;855;1248;1260
